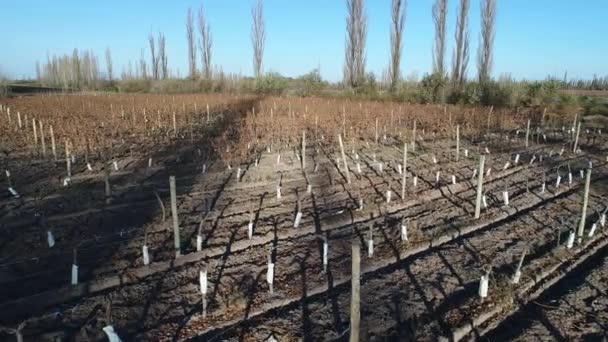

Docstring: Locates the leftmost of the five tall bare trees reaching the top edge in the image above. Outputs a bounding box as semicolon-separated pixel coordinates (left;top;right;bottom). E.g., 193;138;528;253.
344;0;367;87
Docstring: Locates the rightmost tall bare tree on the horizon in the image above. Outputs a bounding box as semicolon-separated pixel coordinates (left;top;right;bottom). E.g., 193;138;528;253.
477;0;496;84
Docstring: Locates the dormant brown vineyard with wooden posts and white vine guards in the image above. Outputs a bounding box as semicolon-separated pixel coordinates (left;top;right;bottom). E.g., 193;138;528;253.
0;94;608;341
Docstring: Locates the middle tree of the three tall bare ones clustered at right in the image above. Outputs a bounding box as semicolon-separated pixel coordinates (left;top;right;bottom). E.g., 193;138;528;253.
452;0;471;89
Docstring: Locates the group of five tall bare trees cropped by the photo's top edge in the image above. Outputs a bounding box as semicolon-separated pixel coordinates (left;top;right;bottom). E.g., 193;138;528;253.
344;0;496;99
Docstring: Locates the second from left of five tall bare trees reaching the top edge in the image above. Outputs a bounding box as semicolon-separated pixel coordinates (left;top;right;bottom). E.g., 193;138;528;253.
388;0;407;91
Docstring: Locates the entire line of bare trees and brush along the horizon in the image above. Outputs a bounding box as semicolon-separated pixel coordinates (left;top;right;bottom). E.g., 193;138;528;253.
29;0;607;103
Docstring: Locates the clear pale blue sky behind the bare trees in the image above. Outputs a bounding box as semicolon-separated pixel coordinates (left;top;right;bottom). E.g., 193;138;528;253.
0;0;608;81
